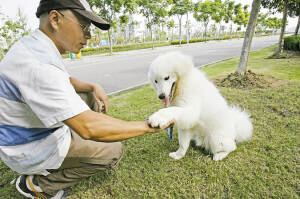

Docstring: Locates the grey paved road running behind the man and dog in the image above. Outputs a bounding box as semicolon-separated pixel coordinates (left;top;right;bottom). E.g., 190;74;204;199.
65;36;278;94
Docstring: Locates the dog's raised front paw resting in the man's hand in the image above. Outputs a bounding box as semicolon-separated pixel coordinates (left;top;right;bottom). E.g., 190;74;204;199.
149;108;174;128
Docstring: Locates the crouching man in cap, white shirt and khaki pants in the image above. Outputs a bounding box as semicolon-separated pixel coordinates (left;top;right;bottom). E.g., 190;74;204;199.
0;0;171;198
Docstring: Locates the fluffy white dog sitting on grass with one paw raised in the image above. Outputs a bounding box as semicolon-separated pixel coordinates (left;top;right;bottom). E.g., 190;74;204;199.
148;52;253;160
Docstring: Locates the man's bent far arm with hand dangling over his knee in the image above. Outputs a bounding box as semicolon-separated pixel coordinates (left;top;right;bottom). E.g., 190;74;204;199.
70;77;109;113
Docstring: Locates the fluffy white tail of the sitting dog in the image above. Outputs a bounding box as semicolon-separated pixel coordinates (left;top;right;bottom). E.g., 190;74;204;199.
231;106;253;143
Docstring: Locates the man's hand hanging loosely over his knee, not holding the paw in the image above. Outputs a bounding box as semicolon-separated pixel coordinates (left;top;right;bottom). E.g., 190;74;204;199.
93;84;109;113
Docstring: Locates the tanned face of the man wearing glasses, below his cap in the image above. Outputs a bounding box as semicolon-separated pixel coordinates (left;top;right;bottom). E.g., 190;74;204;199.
50;10;91;53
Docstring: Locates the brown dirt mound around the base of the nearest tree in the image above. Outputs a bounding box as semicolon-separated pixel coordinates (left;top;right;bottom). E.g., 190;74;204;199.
213;70;287;89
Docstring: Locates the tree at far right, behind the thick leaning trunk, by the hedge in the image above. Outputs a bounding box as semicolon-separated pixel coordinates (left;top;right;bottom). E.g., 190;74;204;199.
262;0;300;54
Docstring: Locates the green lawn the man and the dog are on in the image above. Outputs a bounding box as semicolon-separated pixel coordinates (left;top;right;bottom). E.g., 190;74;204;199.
0;47;300;199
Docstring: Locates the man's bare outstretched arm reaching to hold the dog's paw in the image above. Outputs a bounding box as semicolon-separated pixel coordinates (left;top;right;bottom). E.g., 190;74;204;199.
64;110;170;142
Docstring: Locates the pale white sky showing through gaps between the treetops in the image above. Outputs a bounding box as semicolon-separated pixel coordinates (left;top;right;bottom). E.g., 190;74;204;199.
0;0;297;29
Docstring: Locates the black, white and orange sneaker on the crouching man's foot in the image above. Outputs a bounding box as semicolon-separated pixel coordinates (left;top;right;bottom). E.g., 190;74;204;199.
16;175;67;199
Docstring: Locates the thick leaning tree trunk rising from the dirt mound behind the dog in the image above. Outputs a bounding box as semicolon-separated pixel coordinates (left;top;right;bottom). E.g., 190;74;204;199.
237;0;262;75
